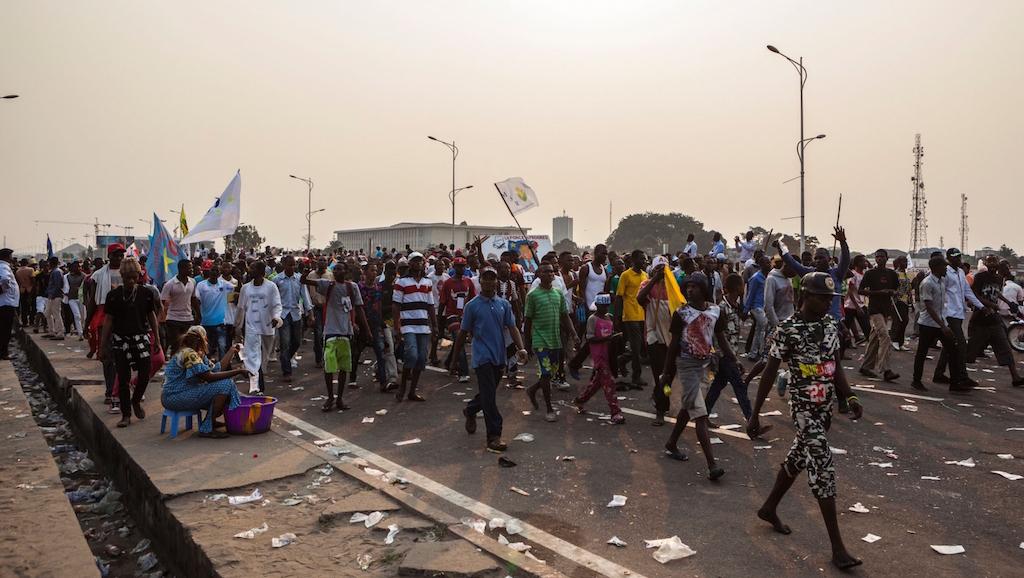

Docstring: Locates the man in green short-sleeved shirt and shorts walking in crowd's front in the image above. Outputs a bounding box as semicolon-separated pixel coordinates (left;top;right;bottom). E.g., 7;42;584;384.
524;263;579;421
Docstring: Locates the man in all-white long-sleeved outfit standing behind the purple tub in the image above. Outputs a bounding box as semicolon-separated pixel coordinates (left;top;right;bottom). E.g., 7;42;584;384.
234;261;283;396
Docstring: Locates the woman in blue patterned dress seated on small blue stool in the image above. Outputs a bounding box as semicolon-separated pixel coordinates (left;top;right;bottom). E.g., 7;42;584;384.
160;325;249;438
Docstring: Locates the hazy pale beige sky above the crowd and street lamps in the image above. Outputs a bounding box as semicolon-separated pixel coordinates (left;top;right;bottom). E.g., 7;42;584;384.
0;0;1024;251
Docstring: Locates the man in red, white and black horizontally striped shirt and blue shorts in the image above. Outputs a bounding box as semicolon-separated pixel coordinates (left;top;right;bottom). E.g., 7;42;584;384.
391;252;437;402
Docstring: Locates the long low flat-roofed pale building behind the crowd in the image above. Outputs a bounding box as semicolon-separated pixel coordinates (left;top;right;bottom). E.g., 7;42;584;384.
334;221;529;252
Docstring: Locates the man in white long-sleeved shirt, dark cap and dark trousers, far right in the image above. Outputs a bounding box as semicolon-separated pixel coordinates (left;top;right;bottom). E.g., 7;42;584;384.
932;247;985;387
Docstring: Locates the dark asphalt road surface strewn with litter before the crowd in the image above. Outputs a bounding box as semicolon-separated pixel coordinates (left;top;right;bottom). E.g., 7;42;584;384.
260;332;1024;576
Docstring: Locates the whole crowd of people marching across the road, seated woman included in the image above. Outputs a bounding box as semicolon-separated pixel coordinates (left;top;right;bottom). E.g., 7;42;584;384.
0;226;1024;568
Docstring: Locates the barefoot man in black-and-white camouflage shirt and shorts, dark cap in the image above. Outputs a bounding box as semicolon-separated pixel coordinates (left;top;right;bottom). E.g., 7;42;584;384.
746;272;864;570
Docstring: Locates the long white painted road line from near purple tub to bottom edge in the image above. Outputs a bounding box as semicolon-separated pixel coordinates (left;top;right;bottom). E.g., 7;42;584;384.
273;407;644;578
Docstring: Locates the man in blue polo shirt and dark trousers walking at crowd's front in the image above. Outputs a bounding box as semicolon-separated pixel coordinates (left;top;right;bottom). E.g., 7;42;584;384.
454;269;526;453
